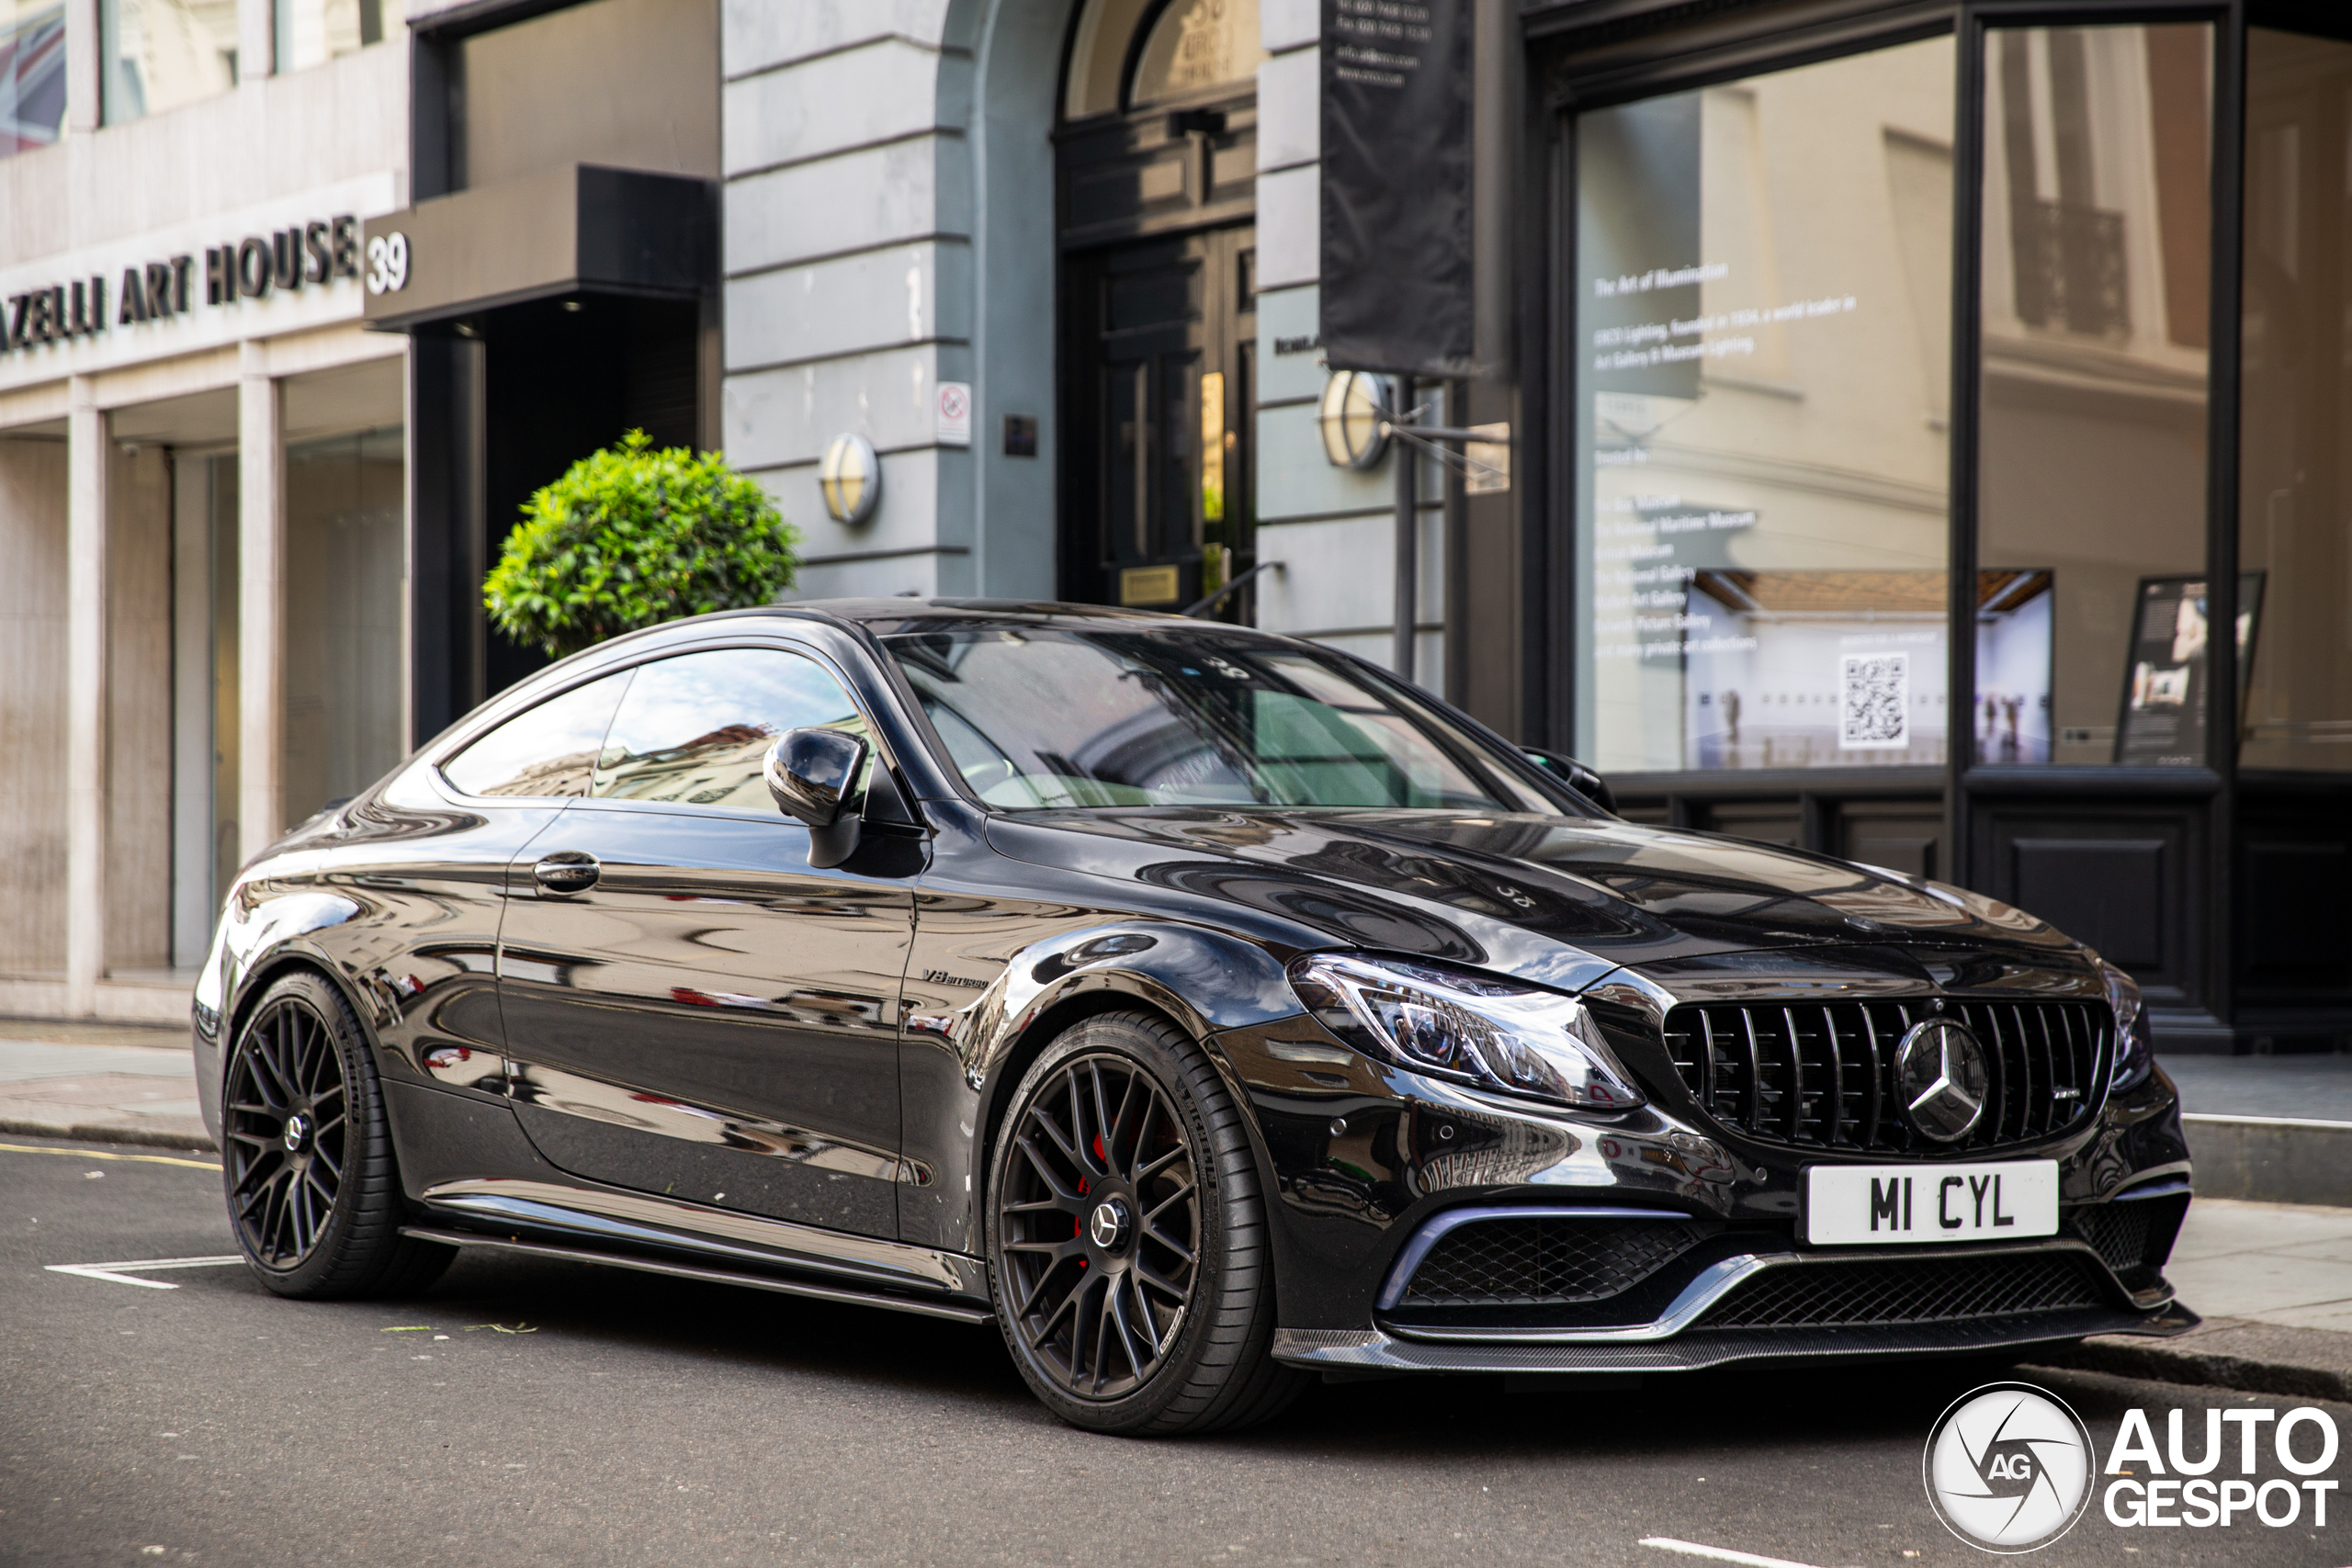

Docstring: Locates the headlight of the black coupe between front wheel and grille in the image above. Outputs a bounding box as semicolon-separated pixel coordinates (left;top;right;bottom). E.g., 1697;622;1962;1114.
1291;954;1642;1110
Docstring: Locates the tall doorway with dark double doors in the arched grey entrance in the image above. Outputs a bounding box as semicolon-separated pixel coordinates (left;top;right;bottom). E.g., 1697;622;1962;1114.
1056;0;1261;618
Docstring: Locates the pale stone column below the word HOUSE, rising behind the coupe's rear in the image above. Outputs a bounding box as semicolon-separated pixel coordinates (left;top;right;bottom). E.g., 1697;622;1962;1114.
238;344;287;861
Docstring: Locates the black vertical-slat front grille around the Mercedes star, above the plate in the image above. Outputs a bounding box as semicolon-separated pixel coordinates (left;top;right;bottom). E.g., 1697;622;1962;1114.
1665;1001;2114;1155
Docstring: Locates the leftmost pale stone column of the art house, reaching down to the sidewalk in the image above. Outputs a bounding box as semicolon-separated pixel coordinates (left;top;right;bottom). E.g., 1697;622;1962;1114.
66;376;110;1018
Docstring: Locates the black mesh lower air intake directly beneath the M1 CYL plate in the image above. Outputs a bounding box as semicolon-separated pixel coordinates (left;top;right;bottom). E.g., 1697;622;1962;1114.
1701;1253;2108;1328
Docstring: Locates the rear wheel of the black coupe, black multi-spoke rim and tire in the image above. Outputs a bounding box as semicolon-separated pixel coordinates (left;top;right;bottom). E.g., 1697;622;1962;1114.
221;971;457;1300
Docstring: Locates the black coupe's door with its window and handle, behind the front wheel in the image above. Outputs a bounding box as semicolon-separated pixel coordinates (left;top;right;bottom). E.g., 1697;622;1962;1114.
499;644;922;1236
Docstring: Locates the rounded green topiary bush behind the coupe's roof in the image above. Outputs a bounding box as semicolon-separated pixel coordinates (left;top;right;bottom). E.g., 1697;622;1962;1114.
482;430;799;659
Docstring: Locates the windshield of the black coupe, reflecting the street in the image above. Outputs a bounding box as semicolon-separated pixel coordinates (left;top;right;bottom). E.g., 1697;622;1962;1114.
882;623;1562;816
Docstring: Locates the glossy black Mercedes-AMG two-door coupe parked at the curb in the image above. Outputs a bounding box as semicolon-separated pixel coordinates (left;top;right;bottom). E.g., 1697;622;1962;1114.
195;600;2194;1434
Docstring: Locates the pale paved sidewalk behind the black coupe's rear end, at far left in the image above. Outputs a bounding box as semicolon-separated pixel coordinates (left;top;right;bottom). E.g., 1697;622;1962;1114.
0;1018;211;1149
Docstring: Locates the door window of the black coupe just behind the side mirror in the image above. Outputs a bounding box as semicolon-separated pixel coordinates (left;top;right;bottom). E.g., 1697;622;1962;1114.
595;649;865;816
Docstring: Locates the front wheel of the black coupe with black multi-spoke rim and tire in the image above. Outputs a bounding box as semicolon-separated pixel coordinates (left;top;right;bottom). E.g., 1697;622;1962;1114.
988;1013;1306;1437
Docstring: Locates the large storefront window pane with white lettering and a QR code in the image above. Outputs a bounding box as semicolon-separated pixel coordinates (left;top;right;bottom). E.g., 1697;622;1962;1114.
1576;40;1954;771
